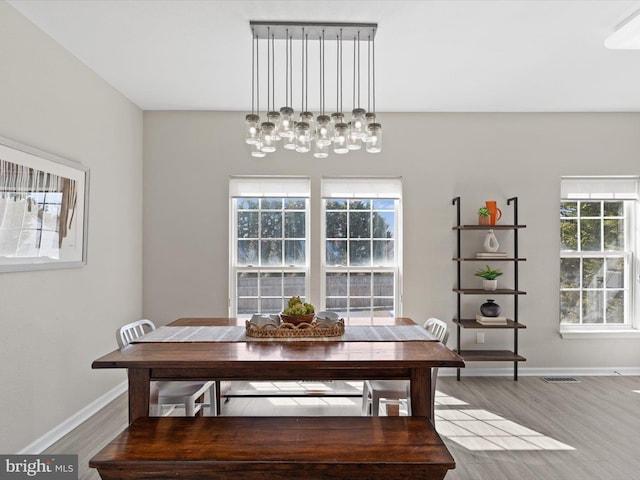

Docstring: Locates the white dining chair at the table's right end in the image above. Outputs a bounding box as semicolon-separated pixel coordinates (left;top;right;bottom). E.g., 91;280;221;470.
362;318;449;418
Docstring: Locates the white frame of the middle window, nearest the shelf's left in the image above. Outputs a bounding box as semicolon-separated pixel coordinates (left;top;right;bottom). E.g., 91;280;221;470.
320;177;403;317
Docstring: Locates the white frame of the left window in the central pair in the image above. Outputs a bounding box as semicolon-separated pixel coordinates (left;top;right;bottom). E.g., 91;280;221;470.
229;176;311;318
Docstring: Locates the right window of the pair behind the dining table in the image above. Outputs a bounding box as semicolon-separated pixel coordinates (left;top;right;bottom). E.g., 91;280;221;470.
322;178;402;317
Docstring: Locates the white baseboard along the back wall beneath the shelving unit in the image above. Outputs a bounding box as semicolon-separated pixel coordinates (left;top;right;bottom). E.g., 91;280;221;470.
438;367;640;377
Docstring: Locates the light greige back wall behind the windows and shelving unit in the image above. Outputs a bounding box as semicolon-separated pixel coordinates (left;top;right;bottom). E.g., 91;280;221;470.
143;112;640;372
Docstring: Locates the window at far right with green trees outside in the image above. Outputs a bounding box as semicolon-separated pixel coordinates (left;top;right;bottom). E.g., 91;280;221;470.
560;177;638;328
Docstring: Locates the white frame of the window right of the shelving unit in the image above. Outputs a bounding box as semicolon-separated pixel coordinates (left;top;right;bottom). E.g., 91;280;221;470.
558;176;640;339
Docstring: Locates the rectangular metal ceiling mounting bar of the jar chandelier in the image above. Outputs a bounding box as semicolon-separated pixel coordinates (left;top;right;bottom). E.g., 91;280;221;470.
249;20;378;40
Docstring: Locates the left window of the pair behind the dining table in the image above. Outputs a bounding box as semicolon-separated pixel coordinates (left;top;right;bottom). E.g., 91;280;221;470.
229;177;310;317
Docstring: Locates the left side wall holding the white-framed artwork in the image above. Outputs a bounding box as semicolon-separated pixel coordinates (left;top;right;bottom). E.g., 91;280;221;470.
0;1;143;453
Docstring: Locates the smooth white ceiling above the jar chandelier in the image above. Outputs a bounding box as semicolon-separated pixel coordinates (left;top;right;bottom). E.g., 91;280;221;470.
8;0;640;112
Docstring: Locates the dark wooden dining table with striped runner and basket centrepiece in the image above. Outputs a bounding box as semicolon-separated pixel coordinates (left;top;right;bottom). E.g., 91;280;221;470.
92;318;464;423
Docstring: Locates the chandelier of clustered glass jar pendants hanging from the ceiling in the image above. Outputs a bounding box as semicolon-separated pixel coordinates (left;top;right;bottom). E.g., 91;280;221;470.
245;21;382;158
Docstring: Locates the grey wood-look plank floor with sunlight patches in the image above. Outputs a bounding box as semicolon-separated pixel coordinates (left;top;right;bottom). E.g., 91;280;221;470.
46;376;640;480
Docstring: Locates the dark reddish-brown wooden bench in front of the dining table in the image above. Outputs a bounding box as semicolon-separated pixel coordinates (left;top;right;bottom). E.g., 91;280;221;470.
89;417;455;480
